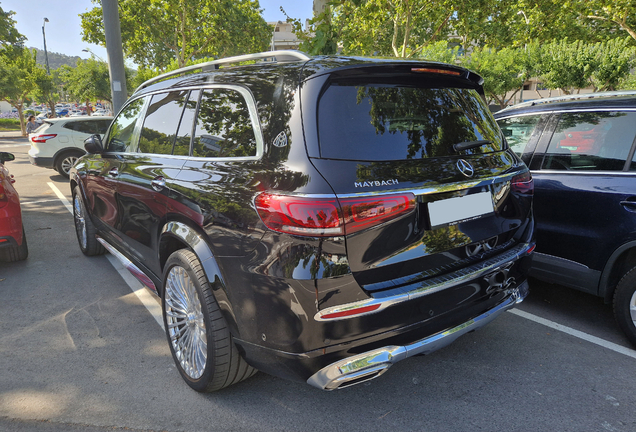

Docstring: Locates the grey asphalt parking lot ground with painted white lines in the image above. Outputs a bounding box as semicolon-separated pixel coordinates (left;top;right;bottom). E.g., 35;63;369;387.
0;138;636;432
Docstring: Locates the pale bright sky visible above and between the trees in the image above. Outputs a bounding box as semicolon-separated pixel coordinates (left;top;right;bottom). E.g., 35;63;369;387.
0;0;313;60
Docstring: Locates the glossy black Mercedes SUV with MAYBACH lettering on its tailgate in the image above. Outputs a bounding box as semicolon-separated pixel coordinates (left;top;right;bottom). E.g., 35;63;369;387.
70;51;534;391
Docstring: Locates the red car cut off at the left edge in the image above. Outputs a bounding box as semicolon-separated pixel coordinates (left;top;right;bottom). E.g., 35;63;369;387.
0;152;29;262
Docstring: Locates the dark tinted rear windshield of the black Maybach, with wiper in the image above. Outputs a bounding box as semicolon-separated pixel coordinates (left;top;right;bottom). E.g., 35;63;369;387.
318;83;504;161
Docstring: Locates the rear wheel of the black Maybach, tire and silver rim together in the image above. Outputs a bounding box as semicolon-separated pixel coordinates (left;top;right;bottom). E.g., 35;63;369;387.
161;249;257;392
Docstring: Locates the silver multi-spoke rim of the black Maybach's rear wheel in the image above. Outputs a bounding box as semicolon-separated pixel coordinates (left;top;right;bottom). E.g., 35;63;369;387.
165;266;208;379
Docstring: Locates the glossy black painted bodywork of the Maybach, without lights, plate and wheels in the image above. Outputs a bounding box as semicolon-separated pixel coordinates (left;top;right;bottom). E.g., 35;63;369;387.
71;58;533;380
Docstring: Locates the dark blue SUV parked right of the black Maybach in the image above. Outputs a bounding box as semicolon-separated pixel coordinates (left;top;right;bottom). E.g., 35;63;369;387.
495;92;636;344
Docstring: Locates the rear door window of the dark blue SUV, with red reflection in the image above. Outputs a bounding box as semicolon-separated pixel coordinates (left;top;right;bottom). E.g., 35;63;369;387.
542;112;636;171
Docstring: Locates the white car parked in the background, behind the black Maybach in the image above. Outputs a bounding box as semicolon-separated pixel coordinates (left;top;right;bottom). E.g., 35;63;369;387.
29;116;113;177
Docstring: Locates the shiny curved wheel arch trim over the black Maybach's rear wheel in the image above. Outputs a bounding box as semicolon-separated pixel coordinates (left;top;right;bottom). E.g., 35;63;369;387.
159;221;240;337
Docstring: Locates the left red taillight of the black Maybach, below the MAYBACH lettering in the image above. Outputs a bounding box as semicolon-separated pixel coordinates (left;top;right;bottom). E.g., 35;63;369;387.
254;193;415;237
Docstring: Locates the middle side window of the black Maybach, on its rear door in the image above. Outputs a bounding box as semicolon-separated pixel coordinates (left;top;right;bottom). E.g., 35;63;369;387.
139;91;188;154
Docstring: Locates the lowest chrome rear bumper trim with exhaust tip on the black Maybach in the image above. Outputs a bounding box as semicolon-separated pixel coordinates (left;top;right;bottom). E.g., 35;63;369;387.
307;281;528;390
